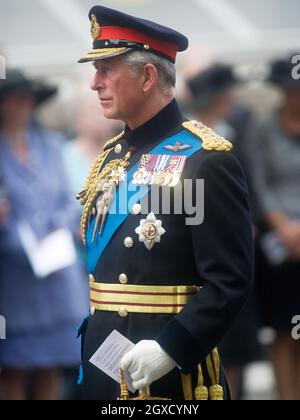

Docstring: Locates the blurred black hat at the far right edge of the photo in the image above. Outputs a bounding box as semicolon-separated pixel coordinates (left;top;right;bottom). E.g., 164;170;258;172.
267;52;300;89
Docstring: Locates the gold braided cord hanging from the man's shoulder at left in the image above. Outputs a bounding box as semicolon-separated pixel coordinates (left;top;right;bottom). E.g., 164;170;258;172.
77;132;130;245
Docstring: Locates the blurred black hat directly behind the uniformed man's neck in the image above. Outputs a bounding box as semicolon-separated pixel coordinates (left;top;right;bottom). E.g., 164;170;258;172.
186;64;240;110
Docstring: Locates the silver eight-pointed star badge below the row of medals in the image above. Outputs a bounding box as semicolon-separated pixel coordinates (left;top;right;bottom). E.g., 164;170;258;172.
135;213;166;251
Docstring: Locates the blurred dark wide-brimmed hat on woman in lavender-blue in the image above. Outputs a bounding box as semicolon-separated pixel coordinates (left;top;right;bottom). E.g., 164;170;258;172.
0;70;57;105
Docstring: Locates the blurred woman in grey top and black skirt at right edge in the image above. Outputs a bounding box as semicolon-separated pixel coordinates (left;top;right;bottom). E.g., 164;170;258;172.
254;57;300;399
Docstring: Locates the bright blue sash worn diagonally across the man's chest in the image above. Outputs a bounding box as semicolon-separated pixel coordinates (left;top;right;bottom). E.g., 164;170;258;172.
86;130;202;273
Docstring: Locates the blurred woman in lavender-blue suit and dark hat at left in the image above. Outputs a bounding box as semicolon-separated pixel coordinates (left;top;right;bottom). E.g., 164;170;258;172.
0;71;86;399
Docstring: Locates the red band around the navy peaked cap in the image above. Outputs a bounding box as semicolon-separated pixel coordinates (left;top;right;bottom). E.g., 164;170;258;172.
97;26;178;61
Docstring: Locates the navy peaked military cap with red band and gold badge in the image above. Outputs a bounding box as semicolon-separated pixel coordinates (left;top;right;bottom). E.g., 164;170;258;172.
79;6;188;63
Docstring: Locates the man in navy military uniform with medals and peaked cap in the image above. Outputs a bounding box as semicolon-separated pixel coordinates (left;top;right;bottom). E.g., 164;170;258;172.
79;6;253;400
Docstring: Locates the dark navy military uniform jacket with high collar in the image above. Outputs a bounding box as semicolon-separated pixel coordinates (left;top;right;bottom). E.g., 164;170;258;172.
82;100;253;400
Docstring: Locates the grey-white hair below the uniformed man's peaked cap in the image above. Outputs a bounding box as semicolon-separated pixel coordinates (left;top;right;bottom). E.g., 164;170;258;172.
124;50;176;95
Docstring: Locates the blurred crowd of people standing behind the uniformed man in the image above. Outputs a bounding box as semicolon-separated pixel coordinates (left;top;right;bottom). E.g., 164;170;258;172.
0;51;300;400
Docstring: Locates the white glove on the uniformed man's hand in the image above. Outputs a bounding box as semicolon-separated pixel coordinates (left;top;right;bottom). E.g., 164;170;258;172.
121;340;176;390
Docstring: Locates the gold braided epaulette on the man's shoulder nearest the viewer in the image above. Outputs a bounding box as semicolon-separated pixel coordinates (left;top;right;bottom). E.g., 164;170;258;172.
182;121;233;152
